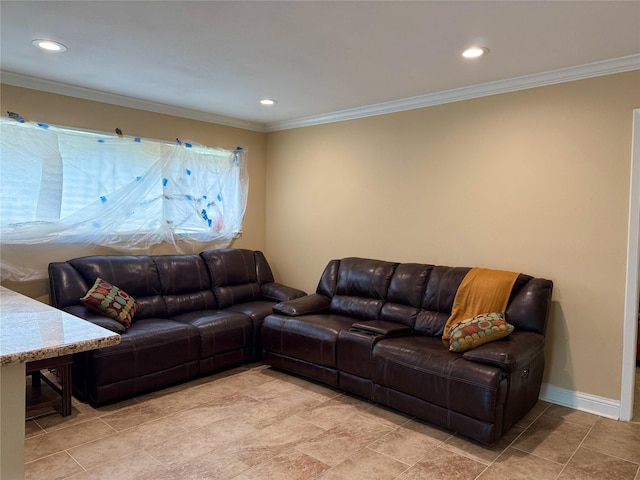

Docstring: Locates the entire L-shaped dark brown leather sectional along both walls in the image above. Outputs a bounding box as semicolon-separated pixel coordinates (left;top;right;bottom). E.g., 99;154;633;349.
49;249;553;444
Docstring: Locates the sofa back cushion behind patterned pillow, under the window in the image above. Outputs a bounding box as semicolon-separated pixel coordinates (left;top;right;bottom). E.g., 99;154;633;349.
67;255;167;321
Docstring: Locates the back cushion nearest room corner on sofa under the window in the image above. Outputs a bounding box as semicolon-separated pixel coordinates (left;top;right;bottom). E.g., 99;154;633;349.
200;248;273;308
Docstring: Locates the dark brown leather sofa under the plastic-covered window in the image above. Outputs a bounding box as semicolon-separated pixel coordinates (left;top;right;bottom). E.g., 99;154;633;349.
49;249;305;405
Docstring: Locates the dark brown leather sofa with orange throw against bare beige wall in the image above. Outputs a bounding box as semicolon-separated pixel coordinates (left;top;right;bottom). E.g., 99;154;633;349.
262;258;553;444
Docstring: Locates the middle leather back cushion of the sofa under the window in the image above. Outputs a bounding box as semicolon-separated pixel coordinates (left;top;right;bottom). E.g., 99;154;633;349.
153;254;216;316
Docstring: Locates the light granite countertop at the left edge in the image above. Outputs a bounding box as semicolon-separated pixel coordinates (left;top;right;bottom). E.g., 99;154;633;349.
0;287;120;366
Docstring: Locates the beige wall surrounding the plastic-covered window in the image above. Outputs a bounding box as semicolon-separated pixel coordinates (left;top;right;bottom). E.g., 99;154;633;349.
0;85;266;301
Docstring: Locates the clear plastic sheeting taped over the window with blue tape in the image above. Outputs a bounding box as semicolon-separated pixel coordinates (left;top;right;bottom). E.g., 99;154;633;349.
0;118;248;281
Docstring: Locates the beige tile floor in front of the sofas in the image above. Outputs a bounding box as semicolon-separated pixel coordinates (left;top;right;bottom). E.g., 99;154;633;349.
25;365;640;480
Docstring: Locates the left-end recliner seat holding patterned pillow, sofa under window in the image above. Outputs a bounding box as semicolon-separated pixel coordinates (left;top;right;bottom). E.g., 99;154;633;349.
49;255;200;404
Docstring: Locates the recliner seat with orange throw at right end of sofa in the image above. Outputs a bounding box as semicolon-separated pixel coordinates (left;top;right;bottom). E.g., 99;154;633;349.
372;266;551;444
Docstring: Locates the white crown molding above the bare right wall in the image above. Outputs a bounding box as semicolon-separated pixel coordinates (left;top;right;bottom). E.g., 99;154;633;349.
266;54;640;132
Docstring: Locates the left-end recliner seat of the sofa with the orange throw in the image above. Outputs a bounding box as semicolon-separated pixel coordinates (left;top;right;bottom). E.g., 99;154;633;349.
262;258;398;387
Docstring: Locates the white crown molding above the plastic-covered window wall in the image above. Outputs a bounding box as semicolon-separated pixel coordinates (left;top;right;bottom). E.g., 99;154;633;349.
0;71;266;132
